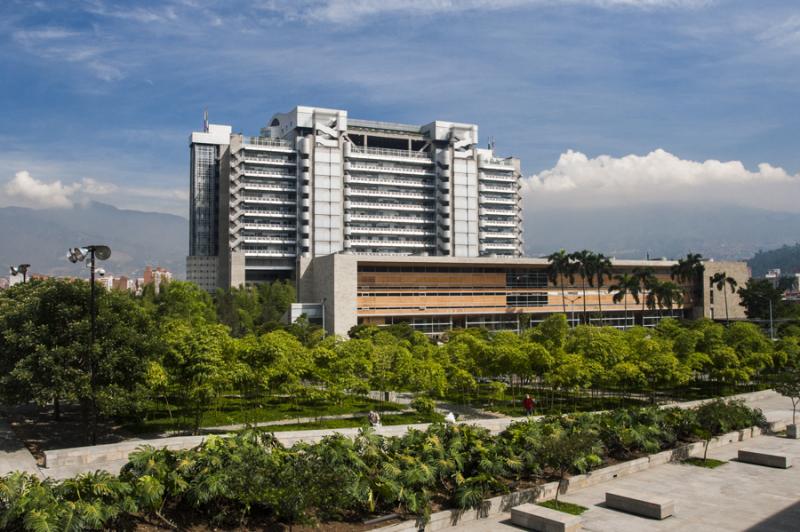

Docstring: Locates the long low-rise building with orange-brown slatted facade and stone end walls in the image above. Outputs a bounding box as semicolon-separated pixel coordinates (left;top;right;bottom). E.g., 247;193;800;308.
291;253;749;335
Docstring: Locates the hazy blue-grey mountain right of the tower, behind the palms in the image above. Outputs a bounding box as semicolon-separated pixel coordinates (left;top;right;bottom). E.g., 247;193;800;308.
523;204;800;260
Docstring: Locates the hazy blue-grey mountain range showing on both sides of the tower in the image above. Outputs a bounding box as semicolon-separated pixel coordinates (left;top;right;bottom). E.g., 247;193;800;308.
0;202;800;278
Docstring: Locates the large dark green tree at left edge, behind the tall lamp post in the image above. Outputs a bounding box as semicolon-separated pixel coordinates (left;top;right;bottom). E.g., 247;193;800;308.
0;279;155;434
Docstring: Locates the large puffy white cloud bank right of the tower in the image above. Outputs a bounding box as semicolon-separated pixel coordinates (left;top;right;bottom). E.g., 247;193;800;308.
526;149;800;192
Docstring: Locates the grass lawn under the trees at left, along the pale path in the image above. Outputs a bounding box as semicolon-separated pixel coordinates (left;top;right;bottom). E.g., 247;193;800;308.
125;396;408;434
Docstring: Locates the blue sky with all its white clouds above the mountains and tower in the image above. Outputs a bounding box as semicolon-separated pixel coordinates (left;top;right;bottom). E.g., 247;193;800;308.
0;0;800;215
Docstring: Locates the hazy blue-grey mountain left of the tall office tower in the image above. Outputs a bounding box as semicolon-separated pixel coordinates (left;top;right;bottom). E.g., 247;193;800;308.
0;202;189;278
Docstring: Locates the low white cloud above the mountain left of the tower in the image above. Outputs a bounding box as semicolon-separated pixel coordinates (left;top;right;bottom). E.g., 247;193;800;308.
0;170;188;210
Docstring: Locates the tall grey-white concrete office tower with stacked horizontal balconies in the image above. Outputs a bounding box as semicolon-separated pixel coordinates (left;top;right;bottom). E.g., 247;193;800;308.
187;107;522;287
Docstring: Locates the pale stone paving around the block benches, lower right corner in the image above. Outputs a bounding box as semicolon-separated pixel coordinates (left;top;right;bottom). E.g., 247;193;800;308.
454;436;800;532
